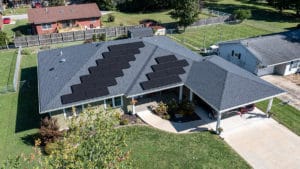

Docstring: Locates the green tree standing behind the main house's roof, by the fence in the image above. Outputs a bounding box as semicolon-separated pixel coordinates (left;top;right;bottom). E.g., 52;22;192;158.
171;0;200;31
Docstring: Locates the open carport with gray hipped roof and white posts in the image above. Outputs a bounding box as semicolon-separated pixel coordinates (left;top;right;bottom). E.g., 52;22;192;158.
185;57;285;131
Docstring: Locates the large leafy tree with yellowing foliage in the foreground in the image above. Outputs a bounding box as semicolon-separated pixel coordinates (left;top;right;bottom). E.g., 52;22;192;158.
3;110;131;169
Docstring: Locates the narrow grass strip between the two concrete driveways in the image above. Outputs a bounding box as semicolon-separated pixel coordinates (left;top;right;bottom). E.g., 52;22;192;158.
256;98;300;136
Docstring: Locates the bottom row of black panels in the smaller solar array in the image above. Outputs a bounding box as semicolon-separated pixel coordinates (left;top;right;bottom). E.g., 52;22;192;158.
141;75;181;90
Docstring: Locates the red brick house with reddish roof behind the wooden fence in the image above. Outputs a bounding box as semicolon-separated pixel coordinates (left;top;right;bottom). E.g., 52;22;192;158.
28;3;101;35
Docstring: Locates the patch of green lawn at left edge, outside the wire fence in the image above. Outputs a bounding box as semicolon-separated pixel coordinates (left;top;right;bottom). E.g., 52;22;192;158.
0;50;17;91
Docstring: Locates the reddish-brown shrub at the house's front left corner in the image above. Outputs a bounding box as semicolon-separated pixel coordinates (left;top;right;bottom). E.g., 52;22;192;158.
39;117;63;145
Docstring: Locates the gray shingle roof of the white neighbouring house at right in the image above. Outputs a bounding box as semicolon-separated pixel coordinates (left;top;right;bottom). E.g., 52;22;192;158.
220;29;300;65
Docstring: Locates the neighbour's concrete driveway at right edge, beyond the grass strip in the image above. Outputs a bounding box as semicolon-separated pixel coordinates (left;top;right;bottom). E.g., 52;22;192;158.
261;75;300;110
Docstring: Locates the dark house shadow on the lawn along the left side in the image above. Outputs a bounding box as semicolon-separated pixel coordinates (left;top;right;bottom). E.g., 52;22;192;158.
15;67;40;132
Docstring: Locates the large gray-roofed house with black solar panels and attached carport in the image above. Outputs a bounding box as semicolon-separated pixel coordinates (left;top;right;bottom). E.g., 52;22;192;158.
38;36;284;130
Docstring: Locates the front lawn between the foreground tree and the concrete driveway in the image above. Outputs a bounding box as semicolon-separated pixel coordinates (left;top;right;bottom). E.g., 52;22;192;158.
122;126;251;169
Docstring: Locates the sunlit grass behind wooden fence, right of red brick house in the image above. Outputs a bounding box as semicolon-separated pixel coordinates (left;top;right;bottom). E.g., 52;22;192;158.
102;10;209;27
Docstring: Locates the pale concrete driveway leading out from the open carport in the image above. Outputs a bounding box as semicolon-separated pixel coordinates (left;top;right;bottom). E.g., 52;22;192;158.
222;118;300;169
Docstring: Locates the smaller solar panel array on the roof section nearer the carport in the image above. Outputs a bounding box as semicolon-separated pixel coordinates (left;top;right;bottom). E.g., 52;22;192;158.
140;55;189;90
